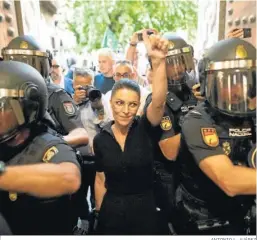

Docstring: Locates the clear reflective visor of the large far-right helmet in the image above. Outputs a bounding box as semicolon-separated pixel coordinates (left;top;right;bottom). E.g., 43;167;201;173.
206;69;256;116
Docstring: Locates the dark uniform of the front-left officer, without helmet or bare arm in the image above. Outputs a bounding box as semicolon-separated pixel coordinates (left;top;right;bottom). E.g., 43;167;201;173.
0;126;80;235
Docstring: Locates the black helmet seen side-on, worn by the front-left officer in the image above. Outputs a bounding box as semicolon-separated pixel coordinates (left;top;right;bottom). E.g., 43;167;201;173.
0;61;48;143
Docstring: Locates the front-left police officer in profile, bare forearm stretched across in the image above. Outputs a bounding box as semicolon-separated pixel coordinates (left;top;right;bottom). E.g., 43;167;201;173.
0;61;81;235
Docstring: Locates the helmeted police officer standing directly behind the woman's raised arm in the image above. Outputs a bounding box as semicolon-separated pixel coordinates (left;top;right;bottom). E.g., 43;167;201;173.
146;33;197;232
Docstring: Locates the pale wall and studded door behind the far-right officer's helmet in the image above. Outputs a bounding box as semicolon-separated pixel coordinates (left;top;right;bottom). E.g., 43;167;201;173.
195;0;256;58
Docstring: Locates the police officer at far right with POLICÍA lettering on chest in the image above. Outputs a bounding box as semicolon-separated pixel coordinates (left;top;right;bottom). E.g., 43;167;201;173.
175;38;256;235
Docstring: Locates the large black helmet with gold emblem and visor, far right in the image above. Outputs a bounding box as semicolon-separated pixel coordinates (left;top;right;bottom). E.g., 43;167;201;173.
204;38;256;117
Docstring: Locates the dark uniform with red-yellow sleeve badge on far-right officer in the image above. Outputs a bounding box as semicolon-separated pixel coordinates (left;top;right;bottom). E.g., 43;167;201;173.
176;103;256;235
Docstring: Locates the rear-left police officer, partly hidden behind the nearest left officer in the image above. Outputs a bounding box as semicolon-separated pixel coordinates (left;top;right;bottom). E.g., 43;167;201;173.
2;35;88;146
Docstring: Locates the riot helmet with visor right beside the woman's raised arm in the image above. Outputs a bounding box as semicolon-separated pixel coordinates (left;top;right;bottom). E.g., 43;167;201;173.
163;32;194;98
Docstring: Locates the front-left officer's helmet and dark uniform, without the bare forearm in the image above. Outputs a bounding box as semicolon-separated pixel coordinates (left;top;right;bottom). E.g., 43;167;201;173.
0;61;80;235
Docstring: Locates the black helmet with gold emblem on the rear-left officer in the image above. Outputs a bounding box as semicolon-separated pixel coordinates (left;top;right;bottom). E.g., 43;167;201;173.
2;35;51;79
